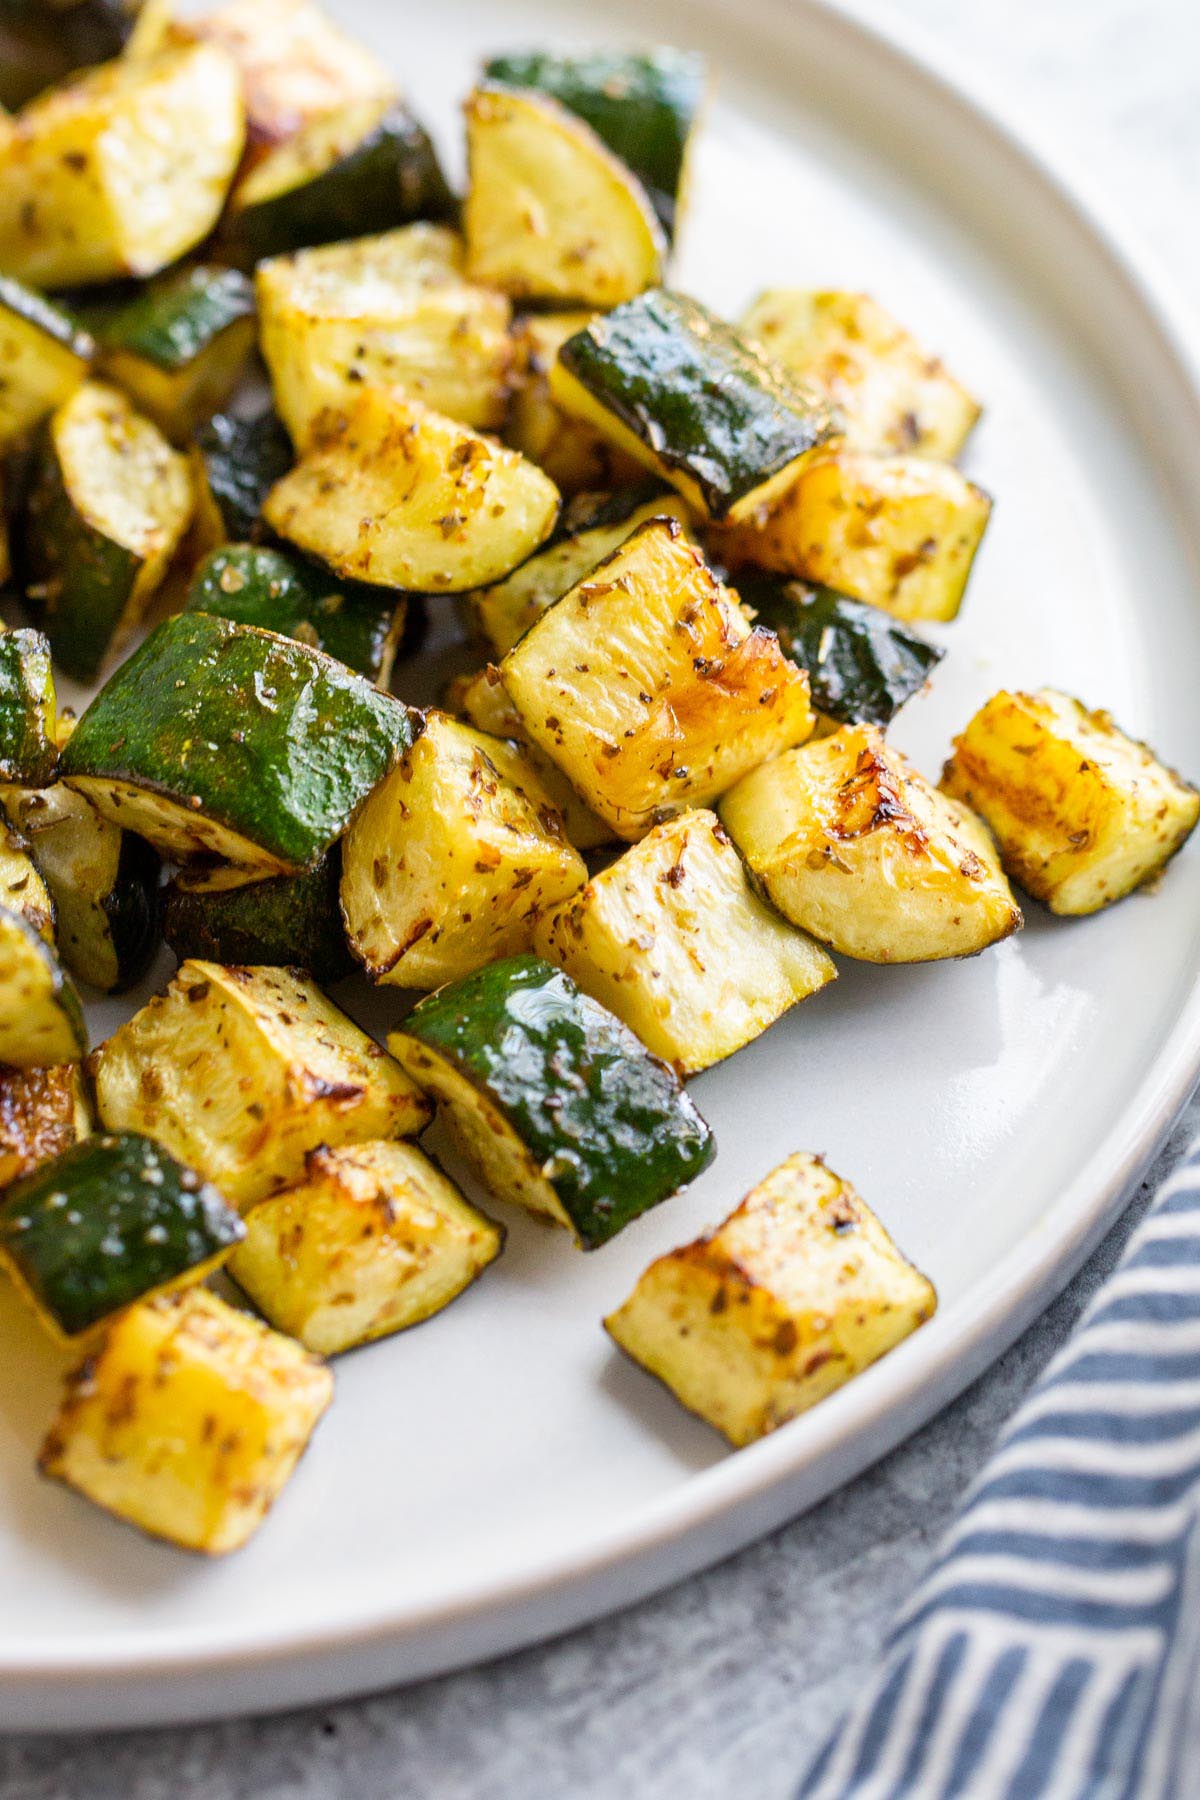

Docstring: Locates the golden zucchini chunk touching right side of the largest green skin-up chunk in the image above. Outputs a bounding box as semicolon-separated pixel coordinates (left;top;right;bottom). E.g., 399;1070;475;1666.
342;713;588;988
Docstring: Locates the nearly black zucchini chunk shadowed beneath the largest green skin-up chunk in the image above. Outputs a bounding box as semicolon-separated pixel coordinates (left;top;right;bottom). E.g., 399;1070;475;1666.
164;844;354;983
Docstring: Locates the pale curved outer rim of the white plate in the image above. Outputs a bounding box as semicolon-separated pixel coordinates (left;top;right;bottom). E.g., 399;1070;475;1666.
0;0;1200;1730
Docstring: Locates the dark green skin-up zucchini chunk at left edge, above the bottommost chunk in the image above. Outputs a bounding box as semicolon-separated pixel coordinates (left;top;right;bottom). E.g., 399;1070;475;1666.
0;1132;246;1337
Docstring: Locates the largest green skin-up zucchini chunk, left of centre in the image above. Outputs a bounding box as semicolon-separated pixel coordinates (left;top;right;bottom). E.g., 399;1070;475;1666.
61;612;412;875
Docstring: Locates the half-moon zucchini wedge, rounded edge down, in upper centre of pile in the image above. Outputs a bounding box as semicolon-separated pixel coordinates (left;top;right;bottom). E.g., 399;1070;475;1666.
263;389;558;594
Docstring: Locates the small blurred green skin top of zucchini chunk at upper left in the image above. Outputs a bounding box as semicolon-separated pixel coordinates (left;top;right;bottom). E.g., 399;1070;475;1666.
95;263;254;373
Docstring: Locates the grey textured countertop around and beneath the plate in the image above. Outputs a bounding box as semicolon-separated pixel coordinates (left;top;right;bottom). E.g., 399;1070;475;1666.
0;0;1200;1800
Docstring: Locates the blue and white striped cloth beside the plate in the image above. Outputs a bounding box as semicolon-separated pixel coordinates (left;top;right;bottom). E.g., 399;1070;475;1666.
799;1143;1200;1800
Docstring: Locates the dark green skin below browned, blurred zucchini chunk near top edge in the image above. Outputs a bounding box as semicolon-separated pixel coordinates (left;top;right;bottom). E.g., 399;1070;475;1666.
228;103;457;263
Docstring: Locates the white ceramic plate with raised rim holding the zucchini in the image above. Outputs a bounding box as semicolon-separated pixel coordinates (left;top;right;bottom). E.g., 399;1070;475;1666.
0;0;1200;1726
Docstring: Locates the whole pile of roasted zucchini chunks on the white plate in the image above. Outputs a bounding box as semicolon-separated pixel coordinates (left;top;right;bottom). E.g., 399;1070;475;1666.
0;0;1200;1552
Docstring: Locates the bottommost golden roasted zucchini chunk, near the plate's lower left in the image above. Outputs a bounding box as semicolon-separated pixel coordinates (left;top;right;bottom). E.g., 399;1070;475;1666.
38;1287;333;1555
